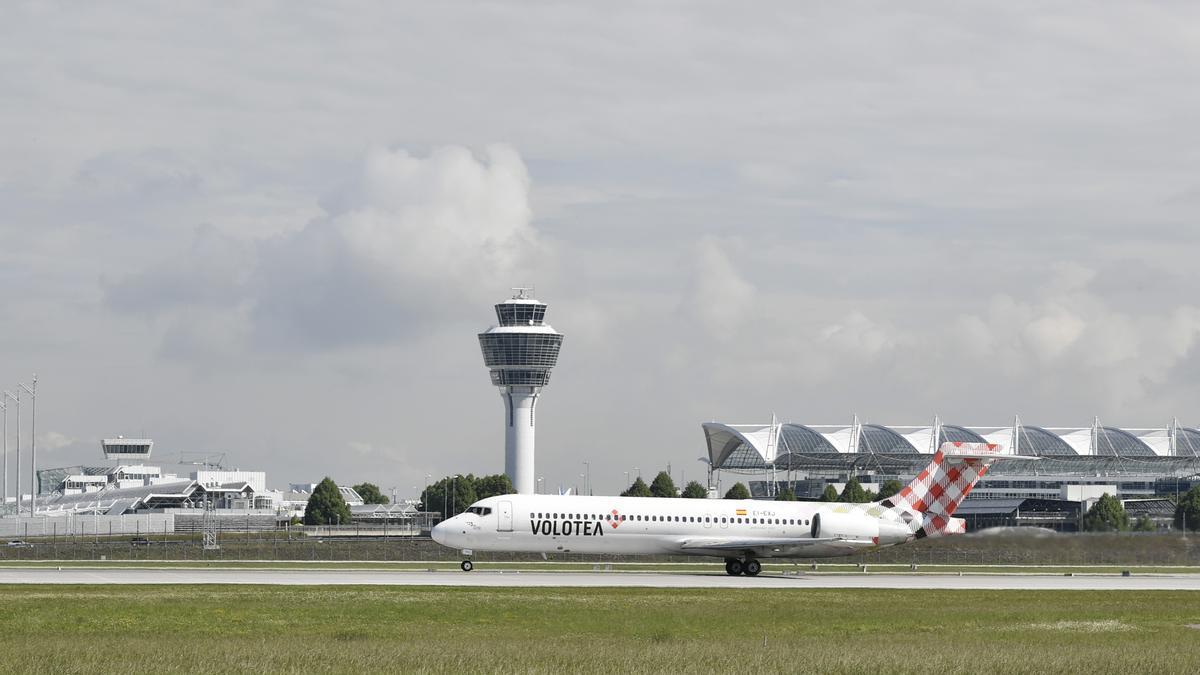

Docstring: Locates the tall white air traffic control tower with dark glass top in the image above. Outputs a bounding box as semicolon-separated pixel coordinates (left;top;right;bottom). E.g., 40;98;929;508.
479;288;563;495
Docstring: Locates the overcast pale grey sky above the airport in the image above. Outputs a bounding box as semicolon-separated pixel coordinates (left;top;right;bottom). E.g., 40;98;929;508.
0;1;1200;496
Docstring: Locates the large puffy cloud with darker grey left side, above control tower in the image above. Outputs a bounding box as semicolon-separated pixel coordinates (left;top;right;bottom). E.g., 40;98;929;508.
107;145;551;356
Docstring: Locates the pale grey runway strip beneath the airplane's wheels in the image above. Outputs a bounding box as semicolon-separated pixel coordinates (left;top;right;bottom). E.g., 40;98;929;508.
0;567;1200;591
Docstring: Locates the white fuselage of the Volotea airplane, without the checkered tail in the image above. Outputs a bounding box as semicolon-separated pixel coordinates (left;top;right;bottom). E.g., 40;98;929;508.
433;487;911;557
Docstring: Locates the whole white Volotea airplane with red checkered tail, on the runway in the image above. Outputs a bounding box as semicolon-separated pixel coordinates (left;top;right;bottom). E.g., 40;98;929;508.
432;442;1022;577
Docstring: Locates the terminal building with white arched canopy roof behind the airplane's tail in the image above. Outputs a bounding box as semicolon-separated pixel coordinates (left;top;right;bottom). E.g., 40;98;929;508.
702;418;1200;503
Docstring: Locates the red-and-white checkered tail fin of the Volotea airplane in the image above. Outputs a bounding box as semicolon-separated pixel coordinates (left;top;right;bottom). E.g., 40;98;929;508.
881;442;1004;537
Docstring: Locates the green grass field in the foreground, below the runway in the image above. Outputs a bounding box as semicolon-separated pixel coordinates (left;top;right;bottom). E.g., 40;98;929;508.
0;586;1200;674
